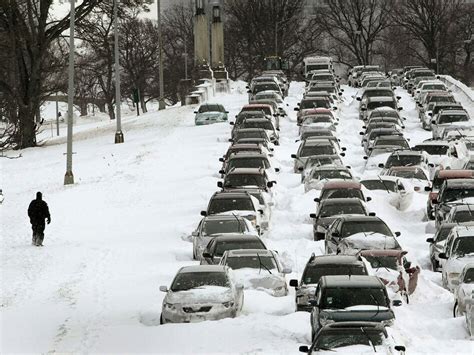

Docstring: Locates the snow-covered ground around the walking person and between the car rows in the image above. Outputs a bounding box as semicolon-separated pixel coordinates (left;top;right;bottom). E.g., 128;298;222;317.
0;83;474;354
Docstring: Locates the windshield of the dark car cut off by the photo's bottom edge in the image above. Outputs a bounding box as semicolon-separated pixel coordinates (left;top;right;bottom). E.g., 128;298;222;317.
314;328;385;350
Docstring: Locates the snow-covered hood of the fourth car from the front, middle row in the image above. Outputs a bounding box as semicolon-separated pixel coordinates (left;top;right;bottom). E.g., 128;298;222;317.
336;233;402;255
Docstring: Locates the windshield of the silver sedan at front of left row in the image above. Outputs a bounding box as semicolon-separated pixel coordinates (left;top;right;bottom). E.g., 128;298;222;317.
171;272;229;292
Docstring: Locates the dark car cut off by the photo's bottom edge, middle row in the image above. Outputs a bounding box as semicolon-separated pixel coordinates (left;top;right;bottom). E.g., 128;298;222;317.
299;321;406;355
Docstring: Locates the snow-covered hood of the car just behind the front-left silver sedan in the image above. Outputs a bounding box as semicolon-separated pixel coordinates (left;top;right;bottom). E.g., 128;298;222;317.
233;268;286;289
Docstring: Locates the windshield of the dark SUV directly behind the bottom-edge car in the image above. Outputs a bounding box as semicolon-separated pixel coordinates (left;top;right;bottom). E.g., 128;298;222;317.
320;287;388;309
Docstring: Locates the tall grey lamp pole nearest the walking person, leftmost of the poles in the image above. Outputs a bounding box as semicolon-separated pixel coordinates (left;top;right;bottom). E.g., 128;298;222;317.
64;0;76;185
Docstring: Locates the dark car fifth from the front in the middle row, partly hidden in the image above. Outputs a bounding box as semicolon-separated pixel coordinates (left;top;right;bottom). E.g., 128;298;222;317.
309;197;375;240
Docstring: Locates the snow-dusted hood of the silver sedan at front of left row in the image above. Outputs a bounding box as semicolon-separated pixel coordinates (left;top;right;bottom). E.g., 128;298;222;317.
164;286;233;304
